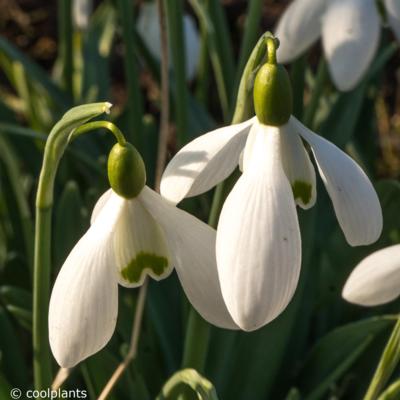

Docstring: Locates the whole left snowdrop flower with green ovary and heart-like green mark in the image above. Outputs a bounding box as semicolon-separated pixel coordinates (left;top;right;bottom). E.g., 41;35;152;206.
49;143;237;367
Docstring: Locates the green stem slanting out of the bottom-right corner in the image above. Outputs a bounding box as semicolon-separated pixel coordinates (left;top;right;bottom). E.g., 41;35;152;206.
364;316;400;400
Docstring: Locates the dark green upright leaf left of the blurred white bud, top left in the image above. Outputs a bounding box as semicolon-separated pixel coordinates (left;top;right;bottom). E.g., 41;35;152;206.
58;0;74;98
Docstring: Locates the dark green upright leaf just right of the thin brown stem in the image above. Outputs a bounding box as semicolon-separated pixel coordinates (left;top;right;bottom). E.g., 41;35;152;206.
164;0;188;145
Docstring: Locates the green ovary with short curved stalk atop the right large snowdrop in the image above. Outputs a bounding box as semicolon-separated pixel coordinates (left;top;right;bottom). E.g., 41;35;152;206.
253;38;293;126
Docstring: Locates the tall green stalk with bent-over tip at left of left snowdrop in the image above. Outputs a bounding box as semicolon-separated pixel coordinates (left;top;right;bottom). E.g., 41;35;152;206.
33;103;114;390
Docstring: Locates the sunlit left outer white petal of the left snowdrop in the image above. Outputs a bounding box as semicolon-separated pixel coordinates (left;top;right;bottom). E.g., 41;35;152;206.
49;192;123;368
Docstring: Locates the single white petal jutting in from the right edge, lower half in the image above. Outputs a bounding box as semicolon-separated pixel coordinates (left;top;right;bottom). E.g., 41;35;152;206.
342;244;400;306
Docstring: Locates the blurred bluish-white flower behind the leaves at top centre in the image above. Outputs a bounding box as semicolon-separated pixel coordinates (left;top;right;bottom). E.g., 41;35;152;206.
137;0;200;80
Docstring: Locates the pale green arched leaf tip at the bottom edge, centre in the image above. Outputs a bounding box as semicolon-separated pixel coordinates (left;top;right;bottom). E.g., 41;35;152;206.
156;369;218;400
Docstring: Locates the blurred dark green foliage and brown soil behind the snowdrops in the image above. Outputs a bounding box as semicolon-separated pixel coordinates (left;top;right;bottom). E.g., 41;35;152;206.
0;0;400;400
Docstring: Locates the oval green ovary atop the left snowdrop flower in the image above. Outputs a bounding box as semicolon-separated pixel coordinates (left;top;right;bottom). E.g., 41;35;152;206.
108;143;146;199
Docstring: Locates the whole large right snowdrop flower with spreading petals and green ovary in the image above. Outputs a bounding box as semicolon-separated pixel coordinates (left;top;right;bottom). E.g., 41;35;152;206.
161;38;382;330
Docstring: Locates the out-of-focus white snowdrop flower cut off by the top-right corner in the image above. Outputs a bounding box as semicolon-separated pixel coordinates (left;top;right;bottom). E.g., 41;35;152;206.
275;0;400;90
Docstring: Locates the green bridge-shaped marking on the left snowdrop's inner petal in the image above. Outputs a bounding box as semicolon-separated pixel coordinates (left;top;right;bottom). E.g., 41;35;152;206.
121;251;168;283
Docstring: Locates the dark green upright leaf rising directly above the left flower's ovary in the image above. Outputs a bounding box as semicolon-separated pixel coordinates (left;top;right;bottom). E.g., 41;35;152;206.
117;0;143;148
